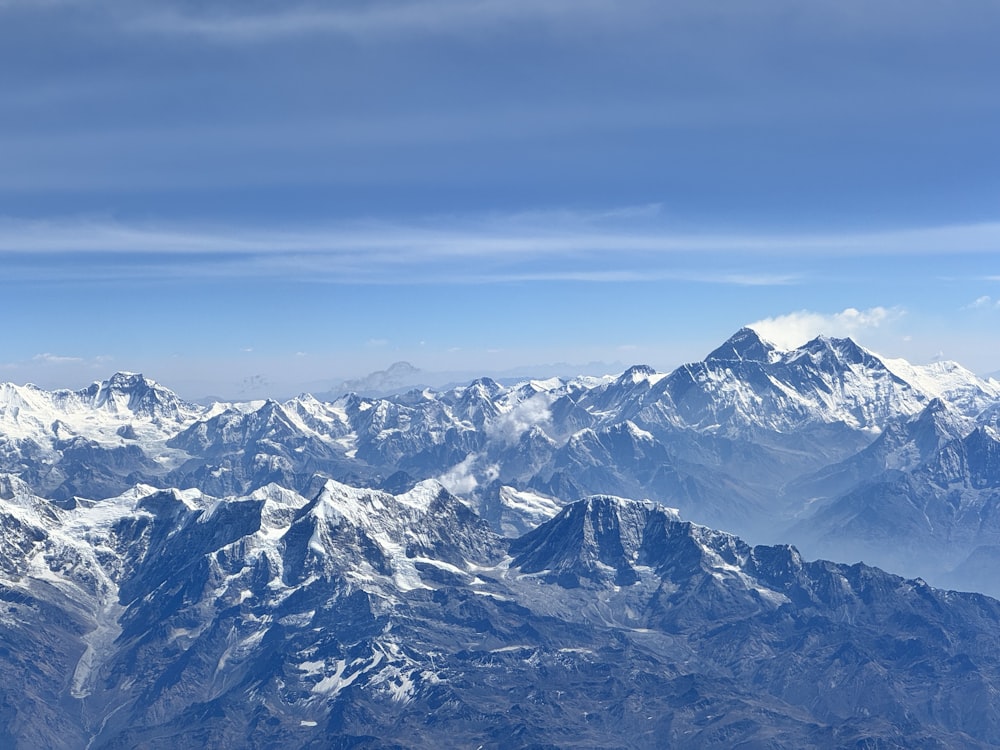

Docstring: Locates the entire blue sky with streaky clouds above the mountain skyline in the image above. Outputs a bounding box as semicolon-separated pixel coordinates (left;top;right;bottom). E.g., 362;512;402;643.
0;0;1000;398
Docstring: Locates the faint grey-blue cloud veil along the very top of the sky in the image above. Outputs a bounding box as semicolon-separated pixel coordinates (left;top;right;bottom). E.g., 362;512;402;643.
60;0;992;42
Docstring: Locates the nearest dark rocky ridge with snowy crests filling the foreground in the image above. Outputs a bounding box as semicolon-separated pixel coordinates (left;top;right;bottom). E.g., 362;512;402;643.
0;477;1000;749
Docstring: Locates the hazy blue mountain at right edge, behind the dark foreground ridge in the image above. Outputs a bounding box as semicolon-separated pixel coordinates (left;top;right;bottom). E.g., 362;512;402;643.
791;407;1000;595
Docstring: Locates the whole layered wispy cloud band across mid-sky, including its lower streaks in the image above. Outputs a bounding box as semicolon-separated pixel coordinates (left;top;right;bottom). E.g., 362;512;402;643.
0;214;1000;286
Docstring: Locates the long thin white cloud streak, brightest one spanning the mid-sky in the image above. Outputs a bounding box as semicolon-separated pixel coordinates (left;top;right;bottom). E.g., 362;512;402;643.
0;213;1000;256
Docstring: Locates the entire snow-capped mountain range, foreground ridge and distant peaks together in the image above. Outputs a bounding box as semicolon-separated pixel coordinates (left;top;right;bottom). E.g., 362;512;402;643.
0;329;1000;750
